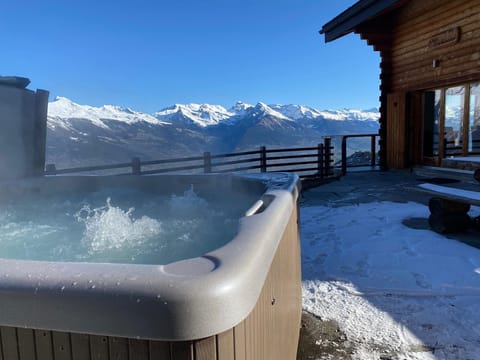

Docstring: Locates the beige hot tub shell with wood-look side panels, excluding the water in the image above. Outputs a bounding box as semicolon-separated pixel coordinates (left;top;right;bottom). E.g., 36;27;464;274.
0;174;301;359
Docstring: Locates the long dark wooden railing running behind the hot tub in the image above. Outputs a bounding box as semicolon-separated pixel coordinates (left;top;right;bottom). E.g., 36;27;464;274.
45;138;333;178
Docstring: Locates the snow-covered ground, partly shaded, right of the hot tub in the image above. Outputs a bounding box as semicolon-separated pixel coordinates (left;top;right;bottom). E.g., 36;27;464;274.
301;175;480;359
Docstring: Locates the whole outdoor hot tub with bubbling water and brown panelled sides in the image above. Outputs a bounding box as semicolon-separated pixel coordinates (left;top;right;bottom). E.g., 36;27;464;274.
0;173;301;360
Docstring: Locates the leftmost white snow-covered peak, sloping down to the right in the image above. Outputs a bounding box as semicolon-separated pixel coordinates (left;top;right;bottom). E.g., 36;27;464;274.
48;96;169;128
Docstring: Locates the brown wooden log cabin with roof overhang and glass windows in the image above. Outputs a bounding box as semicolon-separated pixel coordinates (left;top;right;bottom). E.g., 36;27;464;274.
320;0;480;168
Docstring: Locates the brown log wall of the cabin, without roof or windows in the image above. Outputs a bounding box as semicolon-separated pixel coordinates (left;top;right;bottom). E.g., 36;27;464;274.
355;0;480;168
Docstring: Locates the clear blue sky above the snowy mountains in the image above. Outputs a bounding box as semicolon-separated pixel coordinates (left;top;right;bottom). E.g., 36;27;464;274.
0;0;379;112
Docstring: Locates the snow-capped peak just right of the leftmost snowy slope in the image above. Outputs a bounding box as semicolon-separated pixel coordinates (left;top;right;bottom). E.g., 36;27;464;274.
154;104;235;127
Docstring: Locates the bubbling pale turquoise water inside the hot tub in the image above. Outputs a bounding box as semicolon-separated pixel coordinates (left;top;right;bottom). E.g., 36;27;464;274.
0;187;244;264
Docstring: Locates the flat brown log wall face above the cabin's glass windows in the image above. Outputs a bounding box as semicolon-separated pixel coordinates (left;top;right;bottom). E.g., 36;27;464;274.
389;0;480;92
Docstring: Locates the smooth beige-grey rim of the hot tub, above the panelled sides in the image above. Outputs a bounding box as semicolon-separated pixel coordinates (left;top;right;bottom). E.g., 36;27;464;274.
0;174;298;341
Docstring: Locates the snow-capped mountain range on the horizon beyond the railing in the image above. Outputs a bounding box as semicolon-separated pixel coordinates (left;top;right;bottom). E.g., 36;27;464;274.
47;97;379;168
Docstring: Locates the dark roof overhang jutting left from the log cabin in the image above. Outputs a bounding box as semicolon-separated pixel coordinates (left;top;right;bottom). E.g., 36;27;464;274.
320;0;401;42
